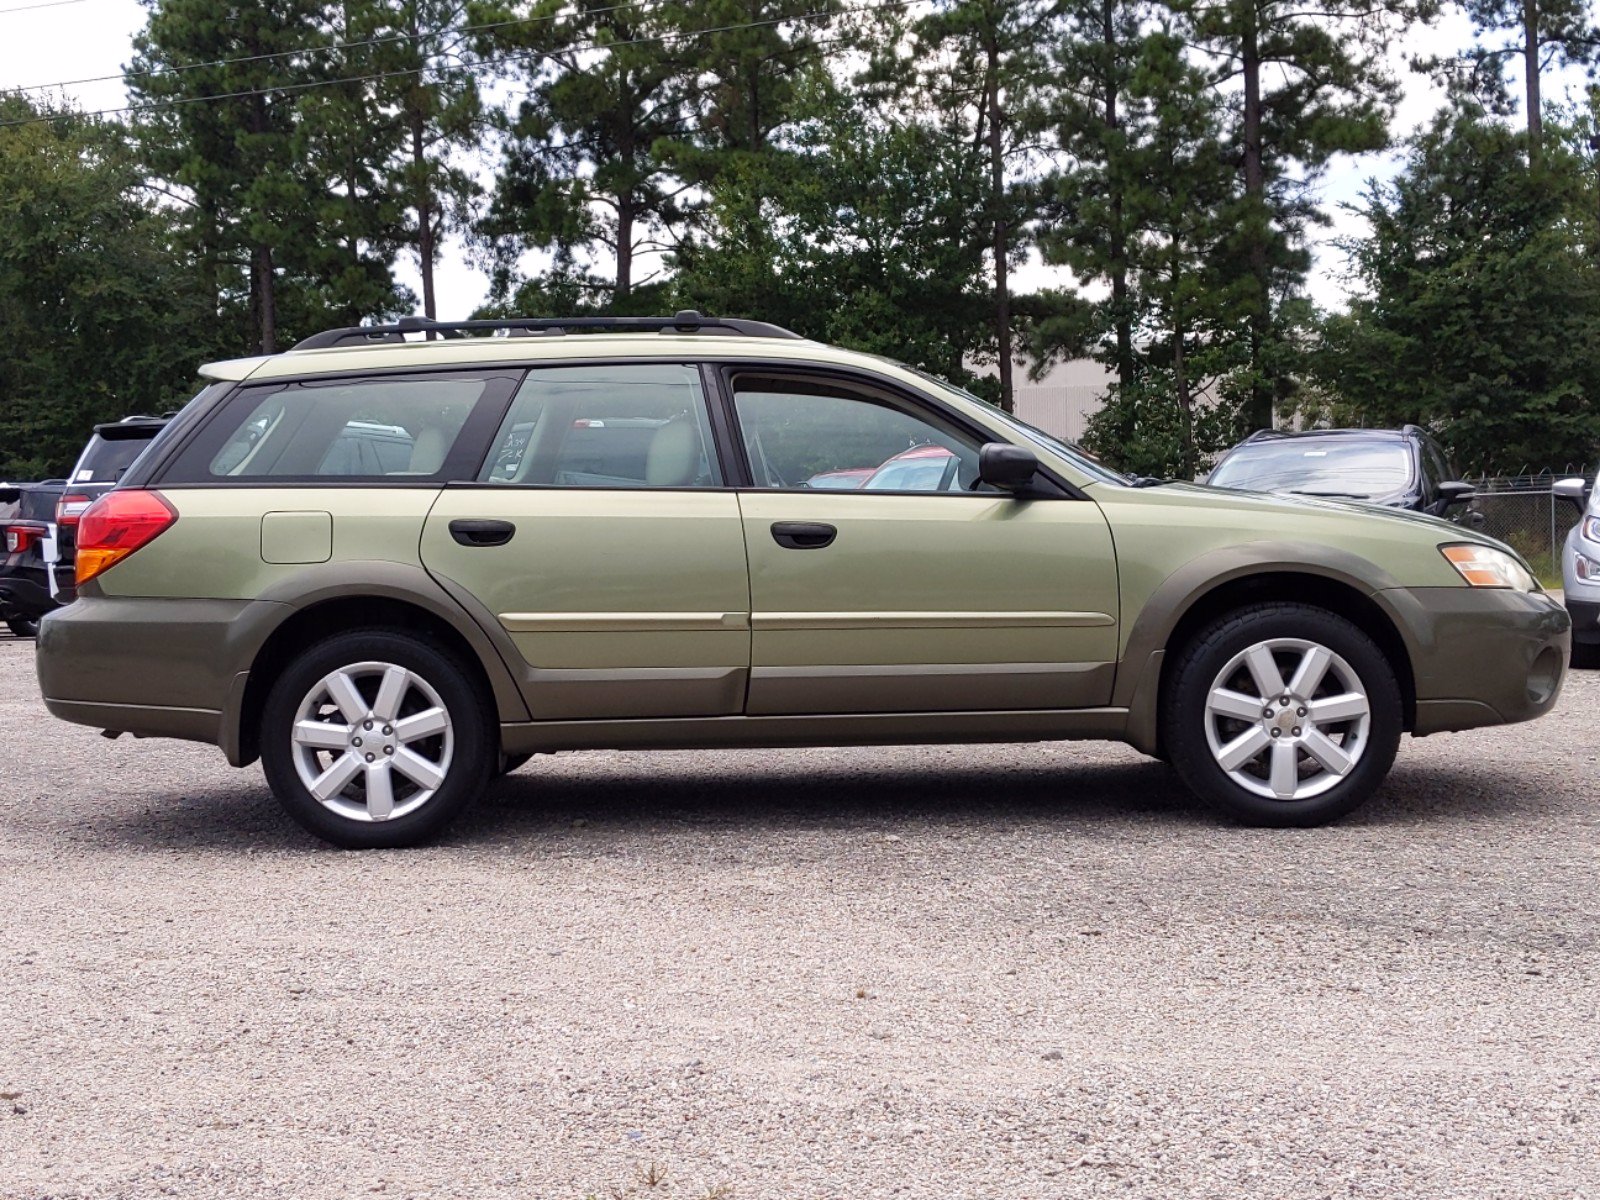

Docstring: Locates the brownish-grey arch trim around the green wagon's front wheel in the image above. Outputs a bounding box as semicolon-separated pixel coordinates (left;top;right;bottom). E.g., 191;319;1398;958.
1114;544;1416;754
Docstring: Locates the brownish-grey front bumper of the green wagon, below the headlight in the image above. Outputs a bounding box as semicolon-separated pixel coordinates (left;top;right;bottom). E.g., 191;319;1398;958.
1381;587;1571;736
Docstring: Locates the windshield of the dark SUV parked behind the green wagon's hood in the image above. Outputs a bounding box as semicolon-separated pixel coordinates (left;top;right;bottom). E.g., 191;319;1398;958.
1206;438;1411;499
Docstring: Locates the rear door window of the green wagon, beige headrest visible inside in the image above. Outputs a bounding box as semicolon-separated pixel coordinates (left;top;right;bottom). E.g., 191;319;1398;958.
478;363;722;488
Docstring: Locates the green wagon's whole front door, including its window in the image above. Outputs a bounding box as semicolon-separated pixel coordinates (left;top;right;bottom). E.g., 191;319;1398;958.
731;373;1117;715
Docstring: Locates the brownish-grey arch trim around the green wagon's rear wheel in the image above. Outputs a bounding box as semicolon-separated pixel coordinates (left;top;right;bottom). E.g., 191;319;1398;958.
222;563;528;766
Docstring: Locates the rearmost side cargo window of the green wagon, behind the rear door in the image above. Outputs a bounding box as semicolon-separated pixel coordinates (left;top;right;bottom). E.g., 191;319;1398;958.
163;371;520;483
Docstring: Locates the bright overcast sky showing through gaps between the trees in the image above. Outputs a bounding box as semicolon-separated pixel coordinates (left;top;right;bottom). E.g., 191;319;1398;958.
0;0;1582;318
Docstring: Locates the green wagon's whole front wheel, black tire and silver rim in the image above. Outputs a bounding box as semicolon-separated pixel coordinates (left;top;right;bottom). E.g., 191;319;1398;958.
1162;603;1403;826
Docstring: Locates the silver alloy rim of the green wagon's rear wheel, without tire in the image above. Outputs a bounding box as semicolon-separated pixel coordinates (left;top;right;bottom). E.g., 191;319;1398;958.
290;662;456;821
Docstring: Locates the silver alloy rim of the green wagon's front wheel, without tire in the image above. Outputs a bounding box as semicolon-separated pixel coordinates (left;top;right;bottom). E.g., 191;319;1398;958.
1205;637;1371;800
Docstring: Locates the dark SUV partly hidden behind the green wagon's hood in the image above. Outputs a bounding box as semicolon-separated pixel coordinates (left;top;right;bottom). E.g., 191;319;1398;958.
1206;426;1472;517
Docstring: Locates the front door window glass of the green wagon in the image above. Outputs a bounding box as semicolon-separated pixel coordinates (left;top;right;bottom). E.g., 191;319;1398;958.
733;376;989;493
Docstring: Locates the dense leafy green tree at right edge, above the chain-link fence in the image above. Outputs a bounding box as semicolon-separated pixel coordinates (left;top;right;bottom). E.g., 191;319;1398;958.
1318;106;1600;472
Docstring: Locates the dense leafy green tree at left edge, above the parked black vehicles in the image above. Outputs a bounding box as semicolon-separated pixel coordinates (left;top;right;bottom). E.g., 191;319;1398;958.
0;96;219;480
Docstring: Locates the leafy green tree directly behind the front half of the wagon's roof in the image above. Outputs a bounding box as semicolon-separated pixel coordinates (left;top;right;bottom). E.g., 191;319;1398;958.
677;90;990;395
